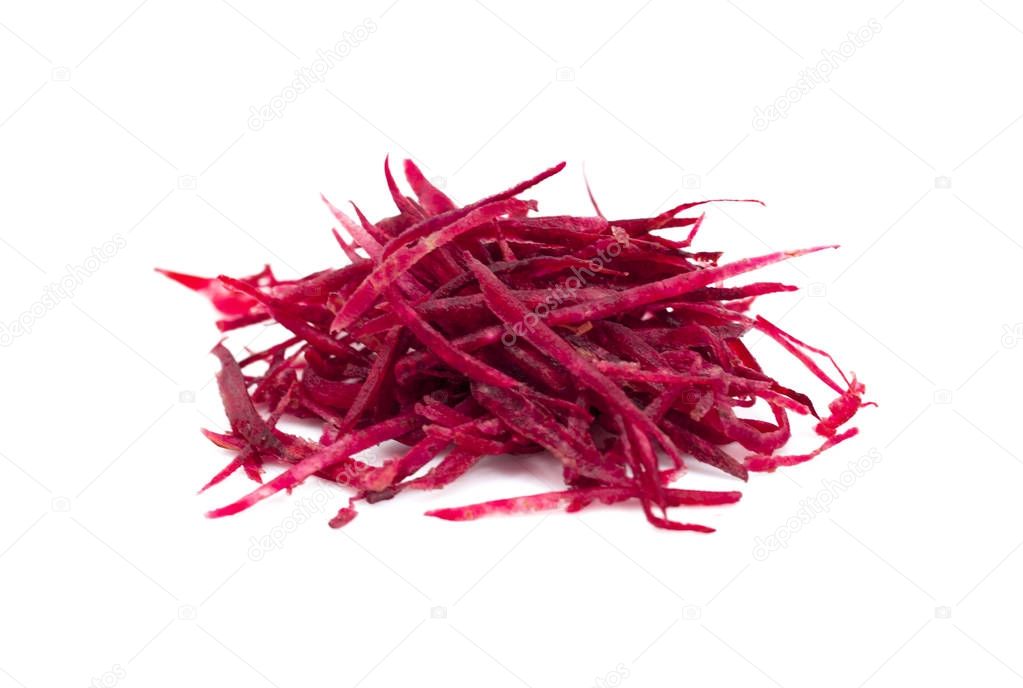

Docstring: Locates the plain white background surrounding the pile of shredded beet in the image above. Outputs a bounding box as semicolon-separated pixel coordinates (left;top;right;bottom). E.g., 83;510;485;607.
0;0;1023;688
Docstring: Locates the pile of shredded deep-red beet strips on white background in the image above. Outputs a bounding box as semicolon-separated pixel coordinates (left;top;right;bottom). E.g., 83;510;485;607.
161;160;863;532
